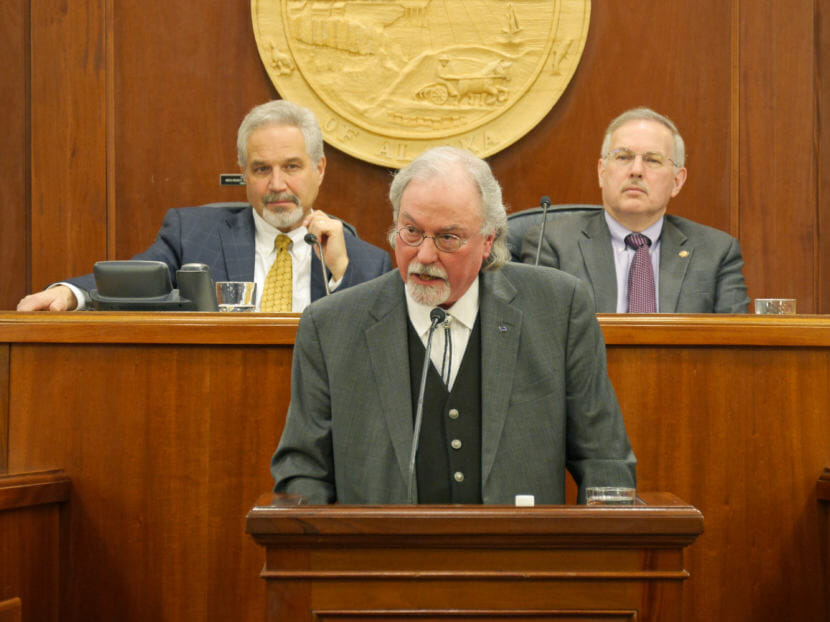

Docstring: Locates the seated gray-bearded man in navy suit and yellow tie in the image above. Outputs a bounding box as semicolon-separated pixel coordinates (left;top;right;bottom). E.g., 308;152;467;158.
17;100;392;313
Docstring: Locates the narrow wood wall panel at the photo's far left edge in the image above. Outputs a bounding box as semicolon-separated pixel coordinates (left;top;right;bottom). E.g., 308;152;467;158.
0;0;30;312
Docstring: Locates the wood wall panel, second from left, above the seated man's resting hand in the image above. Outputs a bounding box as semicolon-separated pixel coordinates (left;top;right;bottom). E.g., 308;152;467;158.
31;0;108;290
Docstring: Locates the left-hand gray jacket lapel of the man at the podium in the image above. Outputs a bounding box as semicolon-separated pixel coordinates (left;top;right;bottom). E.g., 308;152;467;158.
364;270;413;482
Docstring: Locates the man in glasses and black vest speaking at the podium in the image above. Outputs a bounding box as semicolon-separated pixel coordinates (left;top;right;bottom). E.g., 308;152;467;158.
271;147;636;504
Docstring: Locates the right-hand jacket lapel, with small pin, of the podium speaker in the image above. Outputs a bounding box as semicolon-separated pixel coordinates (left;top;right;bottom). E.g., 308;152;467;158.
479;270;522;490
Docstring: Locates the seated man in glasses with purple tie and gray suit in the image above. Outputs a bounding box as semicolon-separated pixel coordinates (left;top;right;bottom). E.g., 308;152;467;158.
522;108;749;313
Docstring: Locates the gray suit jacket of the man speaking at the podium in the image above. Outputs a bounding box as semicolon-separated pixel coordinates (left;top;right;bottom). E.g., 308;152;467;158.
271;264;636;504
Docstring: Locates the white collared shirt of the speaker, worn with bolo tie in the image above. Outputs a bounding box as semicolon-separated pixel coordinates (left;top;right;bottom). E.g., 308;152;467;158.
406;277;479;389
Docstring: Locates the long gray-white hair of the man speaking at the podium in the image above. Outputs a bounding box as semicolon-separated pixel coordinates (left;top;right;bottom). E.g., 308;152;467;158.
389;146;510;270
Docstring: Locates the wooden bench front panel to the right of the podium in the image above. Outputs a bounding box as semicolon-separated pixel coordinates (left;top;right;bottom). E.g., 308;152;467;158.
608;345;830;621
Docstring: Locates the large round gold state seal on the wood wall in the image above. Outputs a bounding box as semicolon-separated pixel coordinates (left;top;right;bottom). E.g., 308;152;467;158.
251;0;591;168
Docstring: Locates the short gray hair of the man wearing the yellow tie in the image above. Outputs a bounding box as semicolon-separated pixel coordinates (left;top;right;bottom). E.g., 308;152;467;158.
236;99;323;169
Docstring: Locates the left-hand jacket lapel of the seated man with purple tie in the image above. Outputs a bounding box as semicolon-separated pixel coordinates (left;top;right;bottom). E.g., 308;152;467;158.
579;211;617;313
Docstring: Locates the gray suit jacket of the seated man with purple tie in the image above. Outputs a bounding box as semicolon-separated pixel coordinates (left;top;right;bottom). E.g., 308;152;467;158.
522;211;749;313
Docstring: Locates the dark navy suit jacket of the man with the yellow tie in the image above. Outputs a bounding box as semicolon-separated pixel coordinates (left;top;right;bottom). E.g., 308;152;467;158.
68;205;392;300
